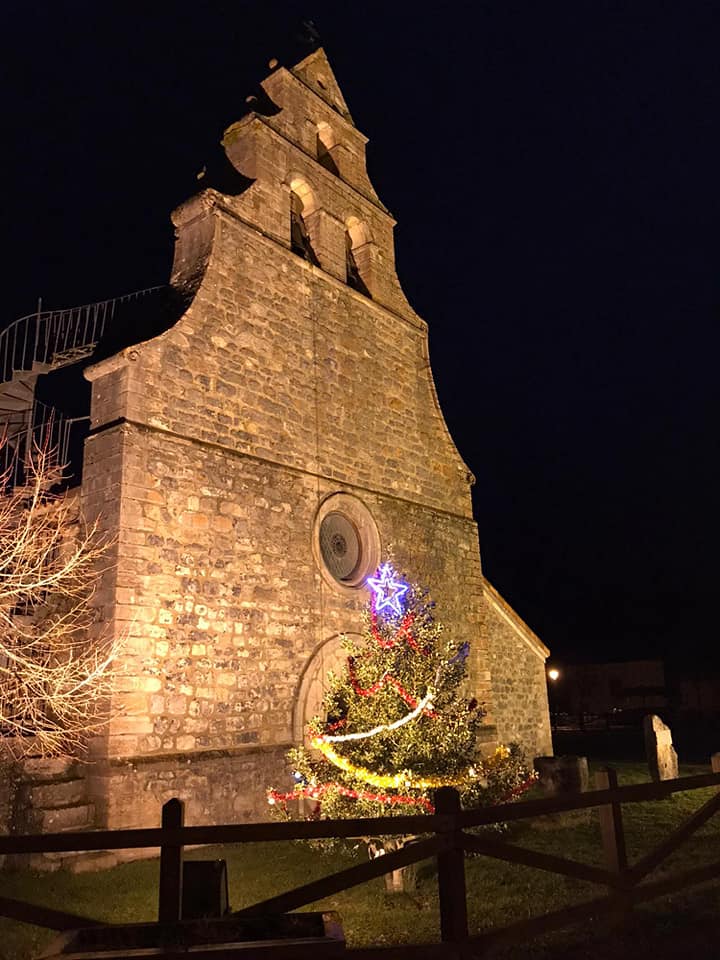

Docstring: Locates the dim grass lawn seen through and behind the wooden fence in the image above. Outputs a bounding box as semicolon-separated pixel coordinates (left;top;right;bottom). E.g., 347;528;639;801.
0;764;720;960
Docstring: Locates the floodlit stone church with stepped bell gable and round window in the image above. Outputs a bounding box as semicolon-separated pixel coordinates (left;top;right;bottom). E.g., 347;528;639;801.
5;50;552;827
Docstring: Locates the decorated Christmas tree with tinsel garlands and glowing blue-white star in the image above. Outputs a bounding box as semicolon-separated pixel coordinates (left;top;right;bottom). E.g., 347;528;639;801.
268;563;533;818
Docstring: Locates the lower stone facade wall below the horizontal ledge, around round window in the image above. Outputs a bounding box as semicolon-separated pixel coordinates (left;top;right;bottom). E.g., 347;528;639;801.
81;410;489;826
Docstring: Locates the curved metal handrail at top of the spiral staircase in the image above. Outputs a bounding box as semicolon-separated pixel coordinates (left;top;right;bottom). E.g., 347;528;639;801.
0;286;163;383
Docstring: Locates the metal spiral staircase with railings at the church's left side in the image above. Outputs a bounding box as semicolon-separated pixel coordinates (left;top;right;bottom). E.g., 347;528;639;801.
0;287;164;486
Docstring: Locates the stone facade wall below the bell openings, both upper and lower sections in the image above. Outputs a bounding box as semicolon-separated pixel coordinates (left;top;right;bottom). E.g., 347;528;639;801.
84;215;489;825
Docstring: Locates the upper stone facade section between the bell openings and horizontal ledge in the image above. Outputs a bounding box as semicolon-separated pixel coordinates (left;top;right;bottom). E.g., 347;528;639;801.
91;213;472;519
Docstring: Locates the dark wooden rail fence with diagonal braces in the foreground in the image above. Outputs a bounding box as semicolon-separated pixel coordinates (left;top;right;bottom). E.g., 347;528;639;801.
0;758;720;960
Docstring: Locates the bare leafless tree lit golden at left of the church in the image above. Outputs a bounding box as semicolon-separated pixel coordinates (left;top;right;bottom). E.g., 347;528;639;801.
0;440;117;758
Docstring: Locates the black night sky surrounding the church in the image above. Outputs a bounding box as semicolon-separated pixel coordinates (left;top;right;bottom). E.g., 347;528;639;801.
0;0;720;670
